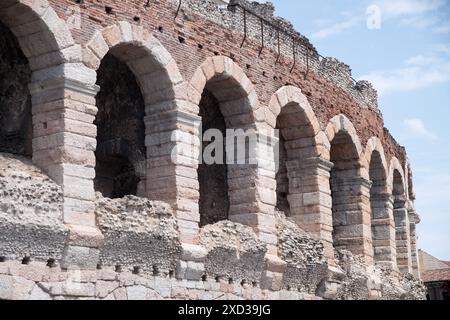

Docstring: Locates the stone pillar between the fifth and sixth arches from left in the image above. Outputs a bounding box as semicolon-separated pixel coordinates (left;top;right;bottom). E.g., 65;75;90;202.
331;177;373;264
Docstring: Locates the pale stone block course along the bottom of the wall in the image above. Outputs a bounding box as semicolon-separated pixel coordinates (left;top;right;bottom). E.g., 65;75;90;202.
0;261;320;300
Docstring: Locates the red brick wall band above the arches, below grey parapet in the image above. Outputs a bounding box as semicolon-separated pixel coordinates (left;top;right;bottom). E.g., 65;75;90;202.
49;0;406;163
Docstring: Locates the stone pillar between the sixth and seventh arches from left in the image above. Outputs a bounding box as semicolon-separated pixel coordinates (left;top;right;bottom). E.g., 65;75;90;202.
370;193;397;270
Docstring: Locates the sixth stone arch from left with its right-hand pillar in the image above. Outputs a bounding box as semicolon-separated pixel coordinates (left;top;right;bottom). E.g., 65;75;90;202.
364;137;397;268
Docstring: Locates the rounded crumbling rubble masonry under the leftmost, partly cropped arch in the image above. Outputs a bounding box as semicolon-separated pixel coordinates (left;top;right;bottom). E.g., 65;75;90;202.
0;153;67;261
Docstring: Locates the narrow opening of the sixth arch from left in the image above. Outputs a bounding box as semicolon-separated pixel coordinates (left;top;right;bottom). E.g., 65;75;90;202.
369;150;395;264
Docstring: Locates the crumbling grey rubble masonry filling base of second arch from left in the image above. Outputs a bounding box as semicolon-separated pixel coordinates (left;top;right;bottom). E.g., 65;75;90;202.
96;193;181;273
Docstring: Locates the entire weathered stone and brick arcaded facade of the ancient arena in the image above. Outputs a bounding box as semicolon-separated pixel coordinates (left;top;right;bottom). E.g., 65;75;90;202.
0;0;423;299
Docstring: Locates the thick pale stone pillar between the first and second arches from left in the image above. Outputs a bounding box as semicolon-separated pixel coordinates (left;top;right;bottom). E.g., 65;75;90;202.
30;75;103;269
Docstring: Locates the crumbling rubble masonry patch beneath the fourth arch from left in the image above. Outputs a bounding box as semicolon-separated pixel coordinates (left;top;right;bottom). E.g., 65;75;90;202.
276;212;328;293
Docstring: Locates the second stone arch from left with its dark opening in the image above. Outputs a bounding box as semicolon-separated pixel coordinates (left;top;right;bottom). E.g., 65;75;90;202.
83;21;183;199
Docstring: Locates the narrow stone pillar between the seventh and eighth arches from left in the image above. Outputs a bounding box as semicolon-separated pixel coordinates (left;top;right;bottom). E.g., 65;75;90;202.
394;197;412;273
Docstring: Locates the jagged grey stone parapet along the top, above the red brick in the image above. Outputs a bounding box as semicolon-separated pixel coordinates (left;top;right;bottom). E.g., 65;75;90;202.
178;0;381;114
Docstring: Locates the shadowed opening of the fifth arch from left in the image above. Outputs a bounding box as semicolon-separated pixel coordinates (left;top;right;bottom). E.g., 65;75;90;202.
330;131;365;254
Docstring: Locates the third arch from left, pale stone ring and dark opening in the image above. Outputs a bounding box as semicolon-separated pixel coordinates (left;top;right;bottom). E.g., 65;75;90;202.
194;57;260;226
